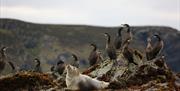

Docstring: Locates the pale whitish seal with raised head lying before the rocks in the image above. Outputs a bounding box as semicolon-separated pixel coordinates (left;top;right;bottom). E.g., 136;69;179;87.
66;65;109;91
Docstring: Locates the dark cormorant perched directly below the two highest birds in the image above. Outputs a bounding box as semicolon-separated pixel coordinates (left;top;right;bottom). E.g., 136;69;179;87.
122;39;137;65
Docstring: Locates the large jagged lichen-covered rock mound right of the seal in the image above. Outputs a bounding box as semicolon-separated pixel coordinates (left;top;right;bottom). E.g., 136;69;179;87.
83;53;177;90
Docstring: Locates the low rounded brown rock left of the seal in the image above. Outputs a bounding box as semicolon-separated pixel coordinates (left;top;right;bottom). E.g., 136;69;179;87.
0;72;57;91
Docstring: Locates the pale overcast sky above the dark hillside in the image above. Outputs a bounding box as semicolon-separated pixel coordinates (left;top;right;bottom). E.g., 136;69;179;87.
0;0;180;30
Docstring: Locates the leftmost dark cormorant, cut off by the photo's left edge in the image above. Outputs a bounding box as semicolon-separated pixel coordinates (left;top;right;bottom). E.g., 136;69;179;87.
0;47;7;73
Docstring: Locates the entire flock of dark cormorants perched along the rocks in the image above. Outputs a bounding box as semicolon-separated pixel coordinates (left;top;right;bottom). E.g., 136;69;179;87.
0;24;164;75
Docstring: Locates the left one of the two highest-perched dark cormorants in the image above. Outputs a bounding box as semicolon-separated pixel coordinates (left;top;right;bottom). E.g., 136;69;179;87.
114;27;123;49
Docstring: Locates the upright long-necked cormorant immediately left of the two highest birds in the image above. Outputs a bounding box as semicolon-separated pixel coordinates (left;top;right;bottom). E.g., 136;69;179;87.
104;33;117;60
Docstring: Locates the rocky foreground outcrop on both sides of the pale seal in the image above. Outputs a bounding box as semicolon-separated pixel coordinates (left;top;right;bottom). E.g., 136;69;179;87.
0;53;180;91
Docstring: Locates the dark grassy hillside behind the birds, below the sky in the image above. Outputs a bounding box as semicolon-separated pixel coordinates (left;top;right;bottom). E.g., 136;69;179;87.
0;18;180;72
